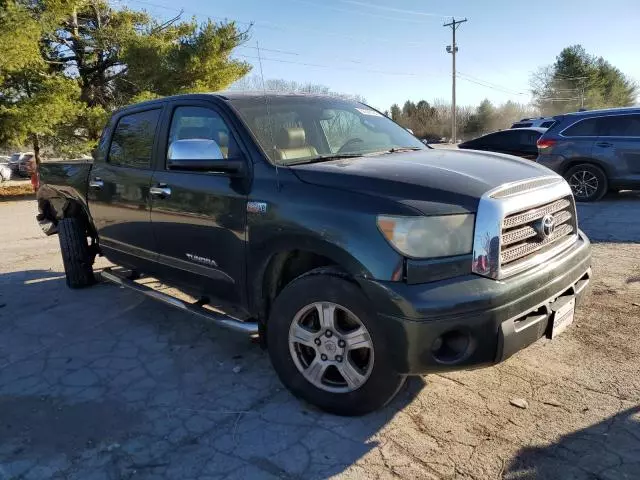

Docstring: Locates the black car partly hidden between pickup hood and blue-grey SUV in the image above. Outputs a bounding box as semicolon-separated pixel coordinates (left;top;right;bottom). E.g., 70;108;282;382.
458;127;546;160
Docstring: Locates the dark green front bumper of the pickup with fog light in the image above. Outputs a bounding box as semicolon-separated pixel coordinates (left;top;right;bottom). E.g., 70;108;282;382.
361;232;591;374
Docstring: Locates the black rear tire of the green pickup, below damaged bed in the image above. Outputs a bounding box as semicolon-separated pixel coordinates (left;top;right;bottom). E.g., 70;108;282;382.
58;218;95;288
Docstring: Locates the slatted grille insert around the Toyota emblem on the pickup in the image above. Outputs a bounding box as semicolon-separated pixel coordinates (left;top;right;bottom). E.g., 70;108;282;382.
500;197;577;266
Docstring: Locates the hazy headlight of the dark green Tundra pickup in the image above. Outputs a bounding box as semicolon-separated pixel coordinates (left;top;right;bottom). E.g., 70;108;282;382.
378;214;475;258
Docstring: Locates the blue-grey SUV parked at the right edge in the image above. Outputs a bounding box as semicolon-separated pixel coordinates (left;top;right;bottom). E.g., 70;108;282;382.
538;107;640;202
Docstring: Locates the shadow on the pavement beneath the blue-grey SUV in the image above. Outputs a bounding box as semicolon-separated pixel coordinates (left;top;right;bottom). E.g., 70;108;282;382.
577;191;640;243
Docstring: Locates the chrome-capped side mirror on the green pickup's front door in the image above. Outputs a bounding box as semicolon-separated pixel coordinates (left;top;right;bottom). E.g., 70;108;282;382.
167;138;245;175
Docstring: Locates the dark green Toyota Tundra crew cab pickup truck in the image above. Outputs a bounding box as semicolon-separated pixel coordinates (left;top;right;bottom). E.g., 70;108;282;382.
37;93;591;415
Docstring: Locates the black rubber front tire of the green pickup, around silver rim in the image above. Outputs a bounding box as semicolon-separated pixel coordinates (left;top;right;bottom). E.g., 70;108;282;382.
267;273;406;416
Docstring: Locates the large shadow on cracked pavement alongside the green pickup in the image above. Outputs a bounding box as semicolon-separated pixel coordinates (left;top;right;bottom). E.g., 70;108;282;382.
0;270;425;478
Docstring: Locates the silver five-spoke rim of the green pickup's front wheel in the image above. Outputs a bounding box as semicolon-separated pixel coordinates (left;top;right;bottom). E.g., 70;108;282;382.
289;302;374;393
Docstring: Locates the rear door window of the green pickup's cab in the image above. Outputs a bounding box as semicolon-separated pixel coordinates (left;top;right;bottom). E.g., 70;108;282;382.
108;109;161;168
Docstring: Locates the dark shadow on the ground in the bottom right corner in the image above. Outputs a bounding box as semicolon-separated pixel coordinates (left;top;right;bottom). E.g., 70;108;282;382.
503;406;640;480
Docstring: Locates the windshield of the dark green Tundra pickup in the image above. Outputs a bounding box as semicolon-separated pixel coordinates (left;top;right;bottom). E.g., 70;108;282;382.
231;95;427;165
